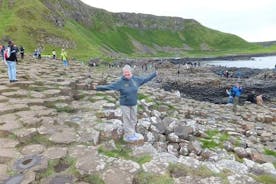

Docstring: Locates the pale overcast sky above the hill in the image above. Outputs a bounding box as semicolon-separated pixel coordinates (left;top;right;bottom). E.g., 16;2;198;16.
82;0;276;42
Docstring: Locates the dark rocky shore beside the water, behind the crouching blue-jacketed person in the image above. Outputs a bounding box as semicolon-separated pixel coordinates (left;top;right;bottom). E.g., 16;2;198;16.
160;65;276;105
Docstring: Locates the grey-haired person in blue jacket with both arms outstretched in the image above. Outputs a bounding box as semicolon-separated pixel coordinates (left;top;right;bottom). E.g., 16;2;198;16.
94;65;157;142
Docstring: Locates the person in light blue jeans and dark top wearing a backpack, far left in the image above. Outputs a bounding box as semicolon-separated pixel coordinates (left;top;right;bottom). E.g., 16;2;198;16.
4;40;17;82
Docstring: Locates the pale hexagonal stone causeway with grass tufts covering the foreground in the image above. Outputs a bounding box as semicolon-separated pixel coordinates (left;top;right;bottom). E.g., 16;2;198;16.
0;58;276;184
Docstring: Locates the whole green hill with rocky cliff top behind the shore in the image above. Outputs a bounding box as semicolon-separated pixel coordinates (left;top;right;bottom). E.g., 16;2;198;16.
0;0;272;59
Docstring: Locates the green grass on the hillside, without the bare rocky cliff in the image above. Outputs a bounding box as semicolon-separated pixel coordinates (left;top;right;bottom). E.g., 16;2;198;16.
0;0;275;59
